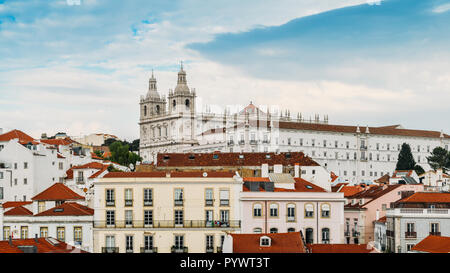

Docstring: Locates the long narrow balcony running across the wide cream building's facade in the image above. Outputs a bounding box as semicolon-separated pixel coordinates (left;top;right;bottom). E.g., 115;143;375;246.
94;220;241;229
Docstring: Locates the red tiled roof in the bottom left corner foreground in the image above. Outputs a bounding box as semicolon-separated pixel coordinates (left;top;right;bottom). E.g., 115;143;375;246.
0;238;88;253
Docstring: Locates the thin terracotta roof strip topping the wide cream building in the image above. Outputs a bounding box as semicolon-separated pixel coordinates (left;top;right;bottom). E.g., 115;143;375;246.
103;171;235;178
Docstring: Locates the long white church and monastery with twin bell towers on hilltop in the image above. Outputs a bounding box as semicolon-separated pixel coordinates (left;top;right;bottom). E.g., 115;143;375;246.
139;65;450;183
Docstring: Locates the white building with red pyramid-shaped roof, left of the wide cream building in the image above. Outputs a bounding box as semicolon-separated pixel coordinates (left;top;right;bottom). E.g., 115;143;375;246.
0;183;94;252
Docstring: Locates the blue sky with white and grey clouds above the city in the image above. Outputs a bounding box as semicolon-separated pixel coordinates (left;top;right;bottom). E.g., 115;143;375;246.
0;0;450;140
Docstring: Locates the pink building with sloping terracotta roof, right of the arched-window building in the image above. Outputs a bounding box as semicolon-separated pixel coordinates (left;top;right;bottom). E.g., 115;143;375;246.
338;184;423;244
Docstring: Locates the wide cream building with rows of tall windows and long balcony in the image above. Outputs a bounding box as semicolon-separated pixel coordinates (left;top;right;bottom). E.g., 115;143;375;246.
94;171;243;253
